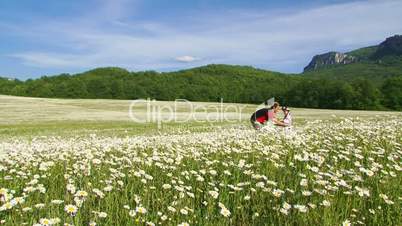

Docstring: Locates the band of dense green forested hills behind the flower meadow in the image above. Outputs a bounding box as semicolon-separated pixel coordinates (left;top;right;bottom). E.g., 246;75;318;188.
0;65;402;110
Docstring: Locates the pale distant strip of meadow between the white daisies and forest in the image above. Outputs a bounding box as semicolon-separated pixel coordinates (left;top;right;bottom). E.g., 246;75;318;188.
0;95;401;138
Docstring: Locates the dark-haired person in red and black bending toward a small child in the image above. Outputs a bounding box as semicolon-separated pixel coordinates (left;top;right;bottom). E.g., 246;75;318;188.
250;102;286;130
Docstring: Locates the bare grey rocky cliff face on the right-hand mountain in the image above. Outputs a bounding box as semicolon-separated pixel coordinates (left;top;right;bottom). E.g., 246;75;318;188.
304;52;358;72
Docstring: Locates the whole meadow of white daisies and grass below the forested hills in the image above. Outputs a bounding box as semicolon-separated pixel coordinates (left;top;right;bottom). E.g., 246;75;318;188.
0;96;402;226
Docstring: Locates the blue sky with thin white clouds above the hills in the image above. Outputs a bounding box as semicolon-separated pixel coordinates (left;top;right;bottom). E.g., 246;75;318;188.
0;0;402;79
